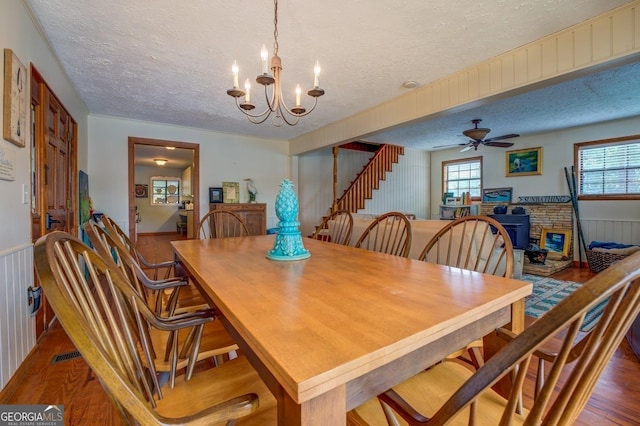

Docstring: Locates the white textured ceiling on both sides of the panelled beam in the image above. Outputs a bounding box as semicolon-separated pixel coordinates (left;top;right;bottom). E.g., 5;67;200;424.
25;0;640;149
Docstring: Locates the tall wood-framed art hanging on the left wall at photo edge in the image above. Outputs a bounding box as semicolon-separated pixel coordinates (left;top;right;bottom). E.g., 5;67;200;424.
2;49;28;147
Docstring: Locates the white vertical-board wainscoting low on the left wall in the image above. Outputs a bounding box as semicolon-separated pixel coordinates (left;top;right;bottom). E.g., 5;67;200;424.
0;244;36;389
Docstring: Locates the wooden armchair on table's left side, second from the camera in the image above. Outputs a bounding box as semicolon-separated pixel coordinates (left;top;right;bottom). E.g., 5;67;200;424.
83;221;238;388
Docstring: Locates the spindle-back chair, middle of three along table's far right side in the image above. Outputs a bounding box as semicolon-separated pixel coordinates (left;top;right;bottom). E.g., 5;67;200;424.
355;212;411;257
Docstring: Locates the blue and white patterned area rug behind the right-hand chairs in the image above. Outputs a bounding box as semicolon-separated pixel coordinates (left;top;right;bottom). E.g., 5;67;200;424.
521;274;606;332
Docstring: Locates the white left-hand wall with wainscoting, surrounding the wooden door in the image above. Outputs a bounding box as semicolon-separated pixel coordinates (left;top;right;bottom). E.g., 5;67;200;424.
0;0;87;388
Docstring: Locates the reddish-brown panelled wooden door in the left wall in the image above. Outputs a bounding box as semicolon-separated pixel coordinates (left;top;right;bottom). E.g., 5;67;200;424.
31;67;78;337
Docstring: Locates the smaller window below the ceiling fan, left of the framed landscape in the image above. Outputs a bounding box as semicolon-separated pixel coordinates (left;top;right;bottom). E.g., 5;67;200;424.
442;157;482;200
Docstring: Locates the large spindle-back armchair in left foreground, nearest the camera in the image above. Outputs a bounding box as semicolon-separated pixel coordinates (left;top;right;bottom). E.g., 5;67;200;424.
34;231;277;425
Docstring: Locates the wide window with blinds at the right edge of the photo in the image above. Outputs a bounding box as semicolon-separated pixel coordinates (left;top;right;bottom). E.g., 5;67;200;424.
574;135;640;200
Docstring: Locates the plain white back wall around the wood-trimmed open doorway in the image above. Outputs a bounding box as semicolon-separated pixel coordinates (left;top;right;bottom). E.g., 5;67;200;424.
89;115;290;229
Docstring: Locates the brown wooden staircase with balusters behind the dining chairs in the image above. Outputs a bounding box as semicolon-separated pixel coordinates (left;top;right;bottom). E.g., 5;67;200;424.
316;142;404;233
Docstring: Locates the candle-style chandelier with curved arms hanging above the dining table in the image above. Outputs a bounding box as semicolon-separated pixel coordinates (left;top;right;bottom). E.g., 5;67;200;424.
227;0;324;127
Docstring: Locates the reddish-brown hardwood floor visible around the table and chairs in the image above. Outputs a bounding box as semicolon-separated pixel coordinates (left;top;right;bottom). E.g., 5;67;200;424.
0;234;640;426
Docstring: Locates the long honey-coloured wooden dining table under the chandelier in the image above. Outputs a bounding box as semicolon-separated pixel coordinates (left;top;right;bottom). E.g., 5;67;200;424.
171;235;532;426
